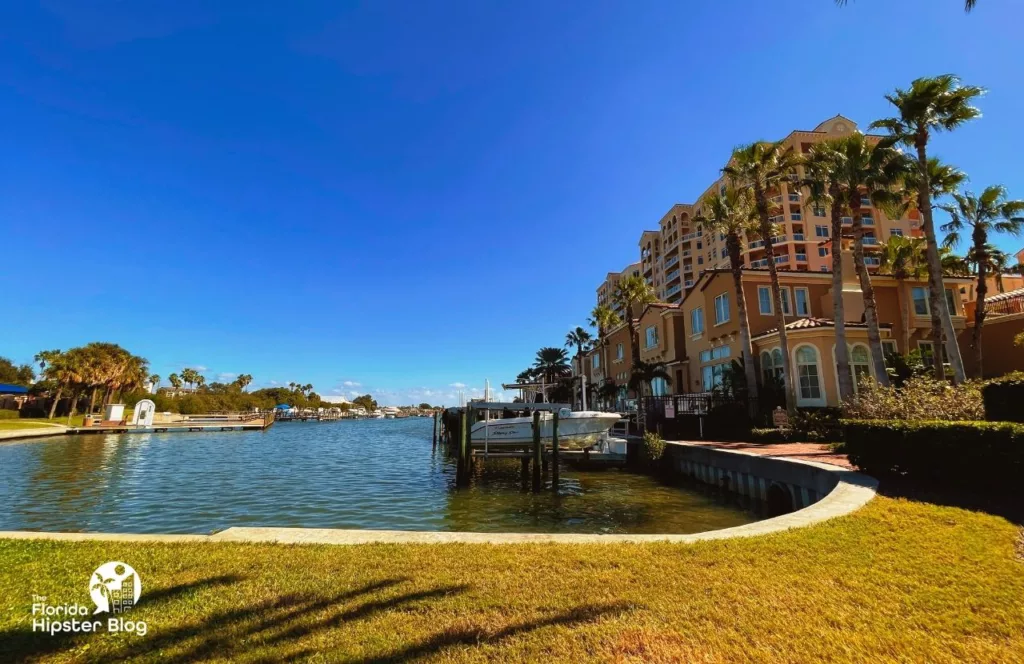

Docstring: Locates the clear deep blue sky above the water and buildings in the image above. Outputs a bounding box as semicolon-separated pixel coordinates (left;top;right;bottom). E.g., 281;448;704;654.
0;0;1024;404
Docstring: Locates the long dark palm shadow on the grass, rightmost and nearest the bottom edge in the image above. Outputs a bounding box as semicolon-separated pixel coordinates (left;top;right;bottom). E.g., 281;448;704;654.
357;601;636;664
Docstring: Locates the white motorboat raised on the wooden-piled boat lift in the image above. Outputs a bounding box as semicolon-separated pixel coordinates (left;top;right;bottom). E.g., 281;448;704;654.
470;409;622;448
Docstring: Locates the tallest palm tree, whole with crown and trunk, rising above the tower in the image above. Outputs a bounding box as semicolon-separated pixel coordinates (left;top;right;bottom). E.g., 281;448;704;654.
871;74;985;383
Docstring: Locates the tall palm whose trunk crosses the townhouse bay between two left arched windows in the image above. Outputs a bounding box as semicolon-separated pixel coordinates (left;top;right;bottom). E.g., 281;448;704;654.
722;141;799;415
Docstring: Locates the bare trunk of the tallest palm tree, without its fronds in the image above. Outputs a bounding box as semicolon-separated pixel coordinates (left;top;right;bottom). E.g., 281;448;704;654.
916;133;966;384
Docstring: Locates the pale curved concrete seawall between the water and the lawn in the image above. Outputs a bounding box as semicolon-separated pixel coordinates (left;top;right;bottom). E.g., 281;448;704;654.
0;443;878;544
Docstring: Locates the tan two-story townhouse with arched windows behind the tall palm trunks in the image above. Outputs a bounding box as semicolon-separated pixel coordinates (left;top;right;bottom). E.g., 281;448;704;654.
677;251;970;407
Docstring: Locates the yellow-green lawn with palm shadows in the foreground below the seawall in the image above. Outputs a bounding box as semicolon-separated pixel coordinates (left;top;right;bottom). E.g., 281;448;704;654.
0;489;1024;662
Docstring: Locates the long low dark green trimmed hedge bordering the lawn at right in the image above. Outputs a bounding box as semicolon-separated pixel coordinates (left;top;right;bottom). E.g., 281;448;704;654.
843;420;1024;490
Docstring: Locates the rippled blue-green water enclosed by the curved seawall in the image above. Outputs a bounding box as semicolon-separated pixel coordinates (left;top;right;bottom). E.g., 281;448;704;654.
0;418;757;533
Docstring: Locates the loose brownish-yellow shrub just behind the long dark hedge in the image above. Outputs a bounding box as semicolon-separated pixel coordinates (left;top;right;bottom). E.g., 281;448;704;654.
843;376;985;421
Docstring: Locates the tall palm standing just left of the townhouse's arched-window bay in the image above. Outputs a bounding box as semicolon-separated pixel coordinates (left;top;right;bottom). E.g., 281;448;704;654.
695;182;759;409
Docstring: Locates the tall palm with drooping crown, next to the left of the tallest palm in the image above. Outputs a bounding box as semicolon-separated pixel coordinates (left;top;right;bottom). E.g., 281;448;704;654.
831;133;909;386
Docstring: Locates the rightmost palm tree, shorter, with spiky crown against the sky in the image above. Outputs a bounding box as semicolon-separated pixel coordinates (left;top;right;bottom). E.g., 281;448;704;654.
940;184;1024;378
